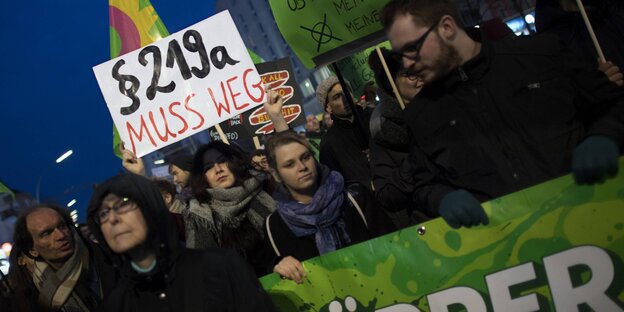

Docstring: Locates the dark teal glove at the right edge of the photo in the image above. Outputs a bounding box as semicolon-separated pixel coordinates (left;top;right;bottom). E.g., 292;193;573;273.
572;135;620;184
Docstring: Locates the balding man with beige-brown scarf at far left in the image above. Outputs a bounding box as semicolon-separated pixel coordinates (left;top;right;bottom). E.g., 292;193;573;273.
8;204;116;311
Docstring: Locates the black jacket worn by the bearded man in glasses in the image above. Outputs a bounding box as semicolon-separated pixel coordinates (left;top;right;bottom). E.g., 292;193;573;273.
405;35;624;216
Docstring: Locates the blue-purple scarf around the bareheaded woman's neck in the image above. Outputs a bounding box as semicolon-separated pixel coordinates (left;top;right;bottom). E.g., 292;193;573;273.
277;166;351;254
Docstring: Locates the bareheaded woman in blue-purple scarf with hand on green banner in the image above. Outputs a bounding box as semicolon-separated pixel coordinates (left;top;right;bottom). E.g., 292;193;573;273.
265;131;390;283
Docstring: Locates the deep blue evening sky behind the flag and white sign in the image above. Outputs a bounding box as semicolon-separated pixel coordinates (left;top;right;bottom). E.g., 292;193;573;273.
0;0;214;222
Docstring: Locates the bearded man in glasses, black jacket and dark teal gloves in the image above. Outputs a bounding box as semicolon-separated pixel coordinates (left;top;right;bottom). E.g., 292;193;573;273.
381;0;624;228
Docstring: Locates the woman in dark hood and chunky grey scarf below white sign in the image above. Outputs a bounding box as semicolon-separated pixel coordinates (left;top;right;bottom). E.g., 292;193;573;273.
185;141;275;276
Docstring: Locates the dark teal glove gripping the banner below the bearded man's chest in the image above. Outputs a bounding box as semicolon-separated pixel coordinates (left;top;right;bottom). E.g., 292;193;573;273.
439;190;490;229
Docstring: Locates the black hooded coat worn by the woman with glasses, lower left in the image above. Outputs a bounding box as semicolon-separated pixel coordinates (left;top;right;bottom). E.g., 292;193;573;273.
88;174;274;311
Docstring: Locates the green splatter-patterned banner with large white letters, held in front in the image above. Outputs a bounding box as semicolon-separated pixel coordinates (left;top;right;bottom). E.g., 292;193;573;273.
261;158;624;312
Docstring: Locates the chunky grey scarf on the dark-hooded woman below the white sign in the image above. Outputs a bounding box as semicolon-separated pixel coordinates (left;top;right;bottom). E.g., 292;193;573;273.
185;177;275;248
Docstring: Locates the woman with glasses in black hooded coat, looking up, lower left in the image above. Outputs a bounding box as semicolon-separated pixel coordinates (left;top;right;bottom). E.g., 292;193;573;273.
88;174;274;311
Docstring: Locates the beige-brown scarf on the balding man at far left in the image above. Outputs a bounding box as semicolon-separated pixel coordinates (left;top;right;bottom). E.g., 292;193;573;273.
18;231;97;311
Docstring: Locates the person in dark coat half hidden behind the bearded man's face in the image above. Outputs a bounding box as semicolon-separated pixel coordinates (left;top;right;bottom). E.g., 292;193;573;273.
368;48;435;228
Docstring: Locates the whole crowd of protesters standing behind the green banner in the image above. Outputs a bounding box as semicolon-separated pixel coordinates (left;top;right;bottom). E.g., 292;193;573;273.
0;0;624;311
